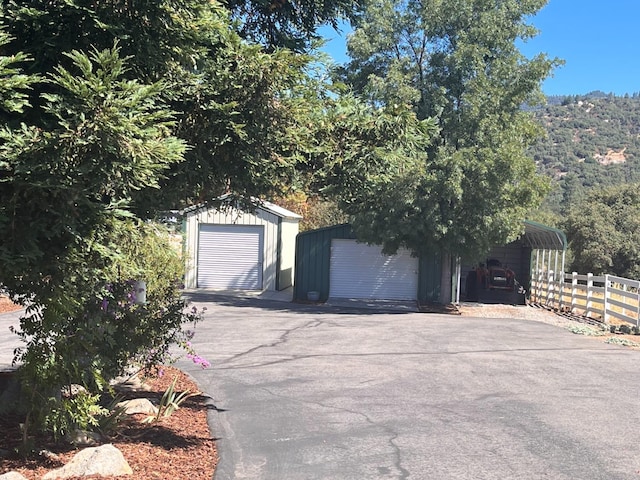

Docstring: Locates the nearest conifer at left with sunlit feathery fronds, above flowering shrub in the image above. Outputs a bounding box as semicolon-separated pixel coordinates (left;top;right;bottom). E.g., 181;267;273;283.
0;45;185;301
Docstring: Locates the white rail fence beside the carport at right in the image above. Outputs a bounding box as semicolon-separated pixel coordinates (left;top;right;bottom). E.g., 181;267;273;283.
531;269;640;327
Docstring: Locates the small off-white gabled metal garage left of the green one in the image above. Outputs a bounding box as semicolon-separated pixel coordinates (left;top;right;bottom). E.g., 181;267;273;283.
185;202;302;290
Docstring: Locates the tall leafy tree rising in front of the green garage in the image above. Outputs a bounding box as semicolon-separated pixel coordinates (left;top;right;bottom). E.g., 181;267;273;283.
337;0;557;300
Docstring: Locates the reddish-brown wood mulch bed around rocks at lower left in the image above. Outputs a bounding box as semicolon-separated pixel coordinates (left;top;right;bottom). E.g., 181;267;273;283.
0;367;217;480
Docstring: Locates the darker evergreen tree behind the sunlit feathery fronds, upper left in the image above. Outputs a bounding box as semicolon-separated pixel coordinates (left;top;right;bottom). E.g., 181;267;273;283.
2;0;311;217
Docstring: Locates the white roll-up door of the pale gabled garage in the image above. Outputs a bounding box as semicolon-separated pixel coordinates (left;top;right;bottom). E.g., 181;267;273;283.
198;224;264;290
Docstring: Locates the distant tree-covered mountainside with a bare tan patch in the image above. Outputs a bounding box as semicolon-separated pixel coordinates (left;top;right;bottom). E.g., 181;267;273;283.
530;91;640;216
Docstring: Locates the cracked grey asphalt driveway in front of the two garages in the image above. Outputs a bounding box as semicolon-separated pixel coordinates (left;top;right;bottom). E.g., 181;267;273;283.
178;296;640;480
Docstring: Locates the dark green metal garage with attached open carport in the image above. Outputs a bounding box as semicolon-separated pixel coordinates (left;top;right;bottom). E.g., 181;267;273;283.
293;221;567;303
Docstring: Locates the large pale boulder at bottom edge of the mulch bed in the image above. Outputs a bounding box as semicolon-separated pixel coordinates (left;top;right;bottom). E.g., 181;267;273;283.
42;444;133;480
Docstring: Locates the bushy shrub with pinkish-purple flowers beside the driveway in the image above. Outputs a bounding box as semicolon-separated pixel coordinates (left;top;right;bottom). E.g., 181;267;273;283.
11;220;201;444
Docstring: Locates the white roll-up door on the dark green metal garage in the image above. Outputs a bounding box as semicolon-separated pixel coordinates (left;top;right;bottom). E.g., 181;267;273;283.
329;239;418;300
